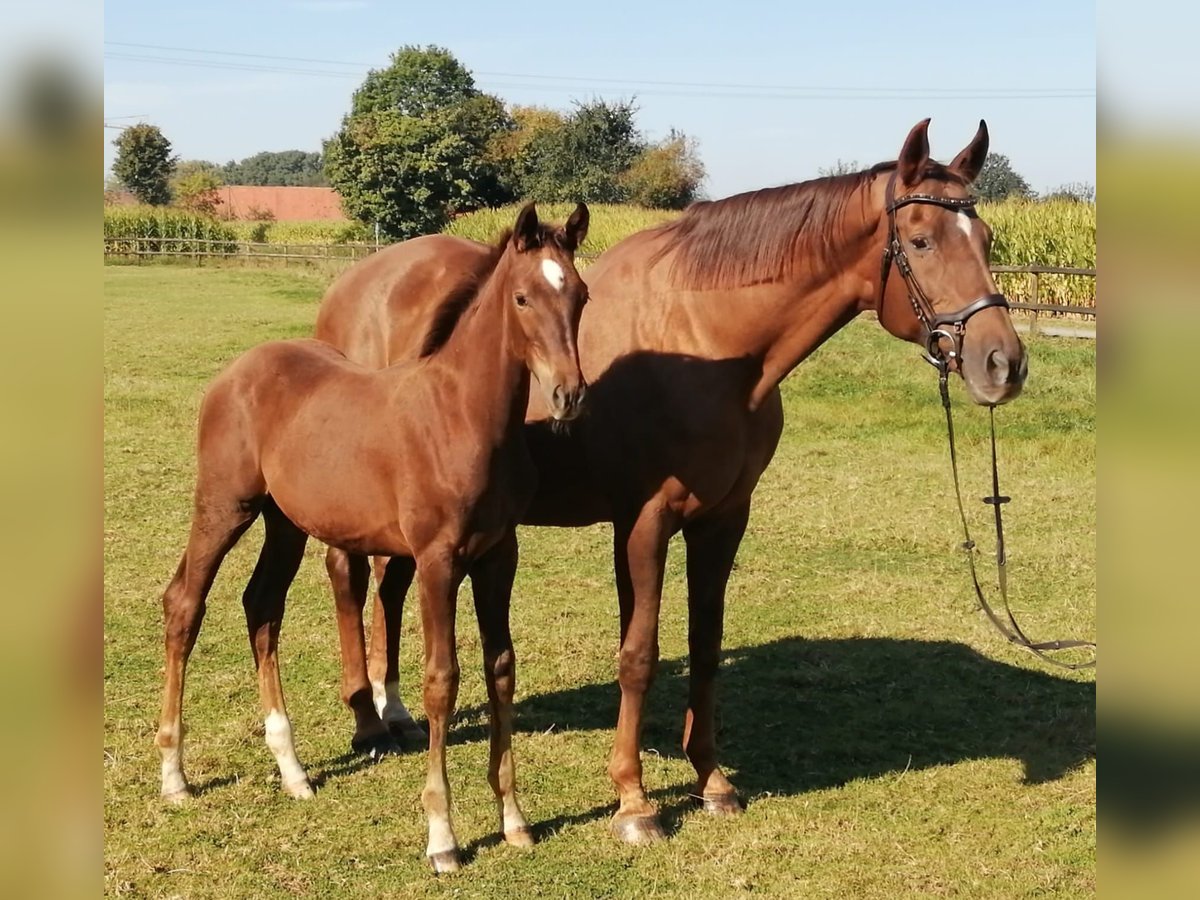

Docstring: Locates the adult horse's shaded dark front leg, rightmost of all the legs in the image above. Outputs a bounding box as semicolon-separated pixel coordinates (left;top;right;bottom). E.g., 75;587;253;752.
683;503;750;815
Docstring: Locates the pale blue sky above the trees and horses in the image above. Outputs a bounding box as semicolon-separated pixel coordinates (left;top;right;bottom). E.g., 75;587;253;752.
104;0;1096;197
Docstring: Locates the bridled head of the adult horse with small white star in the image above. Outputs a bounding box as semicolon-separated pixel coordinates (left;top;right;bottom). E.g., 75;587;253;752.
878;119;1027;406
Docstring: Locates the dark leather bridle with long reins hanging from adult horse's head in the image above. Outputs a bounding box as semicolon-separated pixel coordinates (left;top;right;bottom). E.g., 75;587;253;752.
876;173;1096;670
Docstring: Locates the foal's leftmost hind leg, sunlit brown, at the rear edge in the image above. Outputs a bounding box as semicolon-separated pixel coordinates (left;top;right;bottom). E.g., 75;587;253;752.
155;501;258;803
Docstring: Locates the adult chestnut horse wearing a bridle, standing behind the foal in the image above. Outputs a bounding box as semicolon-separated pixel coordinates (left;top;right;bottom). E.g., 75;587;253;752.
317;120;1026;842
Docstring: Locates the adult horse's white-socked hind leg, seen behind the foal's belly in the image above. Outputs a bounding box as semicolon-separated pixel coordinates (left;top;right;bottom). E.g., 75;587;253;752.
367;557;430;748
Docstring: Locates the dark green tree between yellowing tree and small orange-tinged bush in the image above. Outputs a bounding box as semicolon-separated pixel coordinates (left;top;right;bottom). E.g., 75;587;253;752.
516;100;646;203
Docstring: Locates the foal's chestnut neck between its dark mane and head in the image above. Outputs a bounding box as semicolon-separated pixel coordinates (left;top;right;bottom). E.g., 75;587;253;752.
431;253;529;445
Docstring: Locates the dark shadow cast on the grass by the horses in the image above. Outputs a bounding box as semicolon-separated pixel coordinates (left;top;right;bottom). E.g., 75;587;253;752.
452;637;1096;830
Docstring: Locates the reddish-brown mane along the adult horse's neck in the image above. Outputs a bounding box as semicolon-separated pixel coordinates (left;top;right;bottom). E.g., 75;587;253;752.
650;161;953;290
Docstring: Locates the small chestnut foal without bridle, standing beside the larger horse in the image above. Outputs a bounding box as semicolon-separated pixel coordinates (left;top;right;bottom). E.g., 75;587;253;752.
156;204;587;871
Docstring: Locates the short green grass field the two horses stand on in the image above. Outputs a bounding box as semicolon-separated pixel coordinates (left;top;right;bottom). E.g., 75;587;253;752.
104;266;1096;898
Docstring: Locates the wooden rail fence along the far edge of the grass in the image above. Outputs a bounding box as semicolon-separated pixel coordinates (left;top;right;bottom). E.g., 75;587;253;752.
104;238;1096;330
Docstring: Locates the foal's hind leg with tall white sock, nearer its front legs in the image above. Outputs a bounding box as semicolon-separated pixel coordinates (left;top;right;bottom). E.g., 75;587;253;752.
241;499;312;799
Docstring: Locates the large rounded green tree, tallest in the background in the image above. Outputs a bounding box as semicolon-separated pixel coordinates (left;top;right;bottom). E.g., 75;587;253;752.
325;47;512;239
